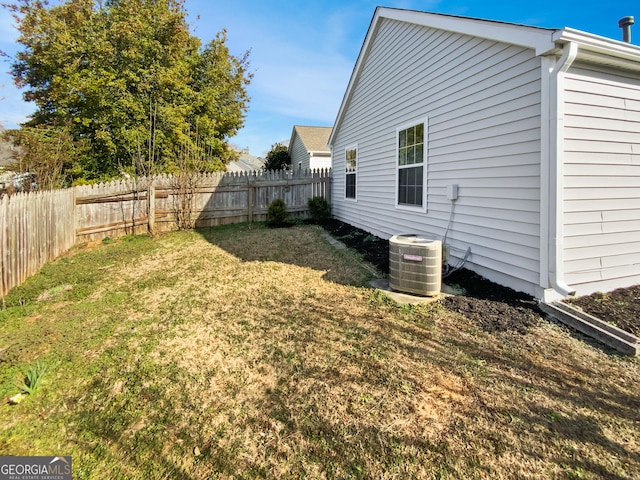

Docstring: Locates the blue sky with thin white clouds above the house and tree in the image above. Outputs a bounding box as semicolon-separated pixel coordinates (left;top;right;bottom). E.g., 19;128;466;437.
0;0;640;156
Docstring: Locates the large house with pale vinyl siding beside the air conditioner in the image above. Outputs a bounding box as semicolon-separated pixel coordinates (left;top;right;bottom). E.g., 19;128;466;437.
329;8;640;301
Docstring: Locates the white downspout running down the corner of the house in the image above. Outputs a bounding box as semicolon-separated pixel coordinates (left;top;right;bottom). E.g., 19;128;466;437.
548;42;578;297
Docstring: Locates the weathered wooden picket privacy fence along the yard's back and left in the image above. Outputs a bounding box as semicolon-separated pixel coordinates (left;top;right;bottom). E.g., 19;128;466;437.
0;170;331;297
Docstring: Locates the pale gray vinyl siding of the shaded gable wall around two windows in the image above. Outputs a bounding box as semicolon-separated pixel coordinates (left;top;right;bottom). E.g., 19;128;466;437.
332;19;541;294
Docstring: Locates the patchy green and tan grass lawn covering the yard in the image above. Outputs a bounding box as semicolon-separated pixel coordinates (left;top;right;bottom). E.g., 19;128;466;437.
0;225;640;479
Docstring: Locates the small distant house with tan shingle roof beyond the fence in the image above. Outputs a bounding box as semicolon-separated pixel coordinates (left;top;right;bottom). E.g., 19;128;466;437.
289;125;331;170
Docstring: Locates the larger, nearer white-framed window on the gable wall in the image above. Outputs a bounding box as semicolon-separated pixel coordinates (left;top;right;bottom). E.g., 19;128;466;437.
397;123;425;208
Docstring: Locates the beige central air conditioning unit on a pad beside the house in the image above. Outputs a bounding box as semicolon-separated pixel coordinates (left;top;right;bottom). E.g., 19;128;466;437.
389;234;442;296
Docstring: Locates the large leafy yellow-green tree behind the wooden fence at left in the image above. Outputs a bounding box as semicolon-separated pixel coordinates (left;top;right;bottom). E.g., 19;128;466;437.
3;0;252;179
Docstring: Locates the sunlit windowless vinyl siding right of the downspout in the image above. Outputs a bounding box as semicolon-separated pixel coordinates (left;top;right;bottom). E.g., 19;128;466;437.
564;65;640;294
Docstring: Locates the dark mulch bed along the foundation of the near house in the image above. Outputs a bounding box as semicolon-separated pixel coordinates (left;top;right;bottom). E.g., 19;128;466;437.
322;220;640;335
